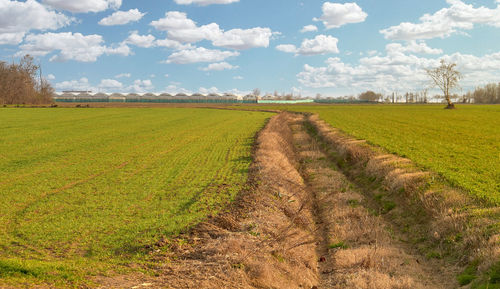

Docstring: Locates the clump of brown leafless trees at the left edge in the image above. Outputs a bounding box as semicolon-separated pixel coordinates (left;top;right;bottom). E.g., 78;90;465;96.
0;55;54;105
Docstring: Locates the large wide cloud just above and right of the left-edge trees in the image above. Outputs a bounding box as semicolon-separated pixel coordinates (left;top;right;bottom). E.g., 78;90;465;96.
17;32;130;62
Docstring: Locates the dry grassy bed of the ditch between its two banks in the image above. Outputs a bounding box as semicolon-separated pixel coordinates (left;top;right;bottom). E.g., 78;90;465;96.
292;115;458;289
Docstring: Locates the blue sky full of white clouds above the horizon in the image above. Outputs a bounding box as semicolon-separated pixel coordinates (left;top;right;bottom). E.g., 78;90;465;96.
0;0;500;97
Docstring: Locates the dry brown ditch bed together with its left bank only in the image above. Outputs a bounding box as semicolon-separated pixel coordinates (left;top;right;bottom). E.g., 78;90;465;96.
95;113;459;289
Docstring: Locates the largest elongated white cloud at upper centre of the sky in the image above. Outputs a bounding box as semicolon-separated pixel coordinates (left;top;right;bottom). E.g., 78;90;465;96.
151;11;273;49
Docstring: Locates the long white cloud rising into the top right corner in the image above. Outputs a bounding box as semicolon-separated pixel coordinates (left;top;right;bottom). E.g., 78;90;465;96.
380;0;500;40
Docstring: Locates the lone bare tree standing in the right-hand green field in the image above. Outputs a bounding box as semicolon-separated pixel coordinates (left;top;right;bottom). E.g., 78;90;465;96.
426;59;462;109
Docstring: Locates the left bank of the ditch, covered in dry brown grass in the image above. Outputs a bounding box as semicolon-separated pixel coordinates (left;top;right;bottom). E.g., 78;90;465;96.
95;115;318;288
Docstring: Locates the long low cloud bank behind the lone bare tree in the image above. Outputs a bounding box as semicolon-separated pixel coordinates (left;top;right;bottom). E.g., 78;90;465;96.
297;45;500;93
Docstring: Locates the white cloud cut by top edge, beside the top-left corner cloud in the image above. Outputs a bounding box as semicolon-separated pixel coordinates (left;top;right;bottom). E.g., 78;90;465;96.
43;0;122;13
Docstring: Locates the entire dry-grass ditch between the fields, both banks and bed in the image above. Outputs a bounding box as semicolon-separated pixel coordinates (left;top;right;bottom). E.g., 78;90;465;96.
94;109;499;289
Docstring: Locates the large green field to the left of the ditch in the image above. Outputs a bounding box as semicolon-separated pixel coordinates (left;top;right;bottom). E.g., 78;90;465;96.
0;108;270;287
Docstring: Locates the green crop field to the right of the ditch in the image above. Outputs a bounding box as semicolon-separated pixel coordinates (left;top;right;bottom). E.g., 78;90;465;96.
258;105;500;205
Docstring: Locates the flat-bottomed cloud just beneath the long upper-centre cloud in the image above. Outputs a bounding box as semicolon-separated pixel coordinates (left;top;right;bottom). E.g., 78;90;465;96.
166;47;240;64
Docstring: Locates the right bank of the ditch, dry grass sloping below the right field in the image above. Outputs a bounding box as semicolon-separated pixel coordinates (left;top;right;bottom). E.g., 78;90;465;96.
308;112;500;288
